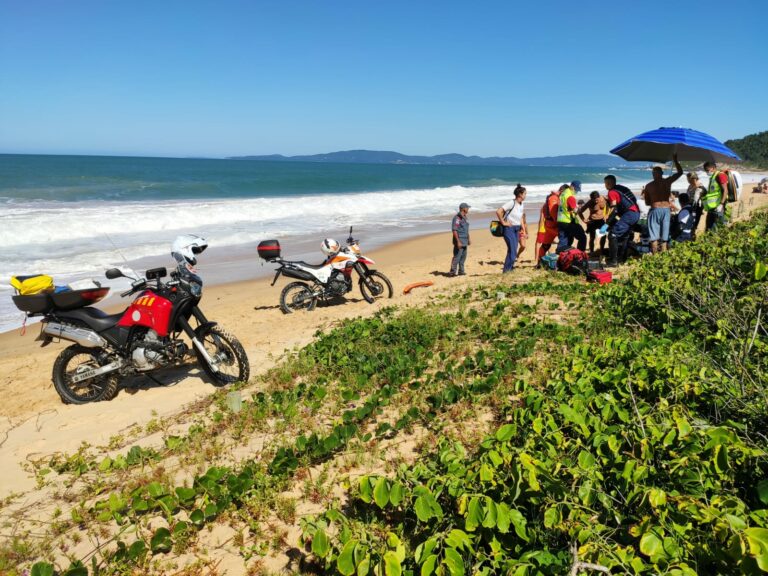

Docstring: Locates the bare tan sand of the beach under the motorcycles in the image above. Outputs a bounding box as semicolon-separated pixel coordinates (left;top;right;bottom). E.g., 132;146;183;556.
0;183;768;497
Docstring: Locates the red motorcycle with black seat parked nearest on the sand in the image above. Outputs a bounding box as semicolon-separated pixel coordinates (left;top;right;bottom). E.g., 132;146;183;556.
13;236;250;404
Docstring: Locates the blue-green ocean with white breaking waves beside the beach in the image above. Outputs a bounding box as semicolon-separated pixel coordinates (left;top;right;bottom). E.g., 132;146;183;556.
0;155;684;331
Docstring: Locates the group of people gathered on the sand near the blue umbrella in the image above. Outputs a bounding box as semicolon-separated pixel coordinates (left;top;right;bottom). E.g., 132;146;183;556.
449;156;736;276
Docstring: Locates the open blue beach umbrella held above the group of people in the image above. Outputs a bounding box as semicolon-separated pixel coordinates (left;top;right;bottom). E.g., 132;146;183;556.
611;128;741;162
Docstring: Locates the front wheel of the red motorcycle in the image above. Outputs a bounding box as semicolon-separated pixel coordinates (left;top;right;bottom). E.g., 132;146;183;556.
195;326;251;386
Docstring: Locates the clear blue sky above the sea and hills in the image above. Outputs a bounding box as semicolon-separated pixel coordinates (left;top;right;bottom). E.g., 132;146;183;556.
0;0;768;157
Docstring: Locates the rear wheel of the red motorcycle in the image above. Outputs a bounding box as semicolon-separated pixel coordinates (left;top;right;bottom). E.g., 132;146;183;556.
53;344;118;404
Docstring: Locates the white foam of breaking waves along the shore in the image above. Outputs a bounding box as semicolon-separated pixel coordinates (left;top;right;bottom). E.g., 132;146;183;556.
0;177;704;331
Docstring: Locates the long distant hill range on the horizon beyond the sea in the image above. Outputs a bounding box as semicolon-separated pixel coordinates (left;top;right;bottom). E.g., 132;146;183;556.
231;150;638;168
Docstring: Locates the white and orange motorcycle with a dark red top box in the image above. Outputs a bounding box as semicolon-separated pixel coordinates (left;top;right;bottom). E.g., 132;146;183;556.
258;227;393;314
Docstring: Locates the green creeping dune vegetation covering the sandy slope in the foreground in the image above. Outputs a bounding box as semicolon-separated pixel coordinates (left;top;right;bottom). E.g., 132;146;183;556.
15;213;768;576
